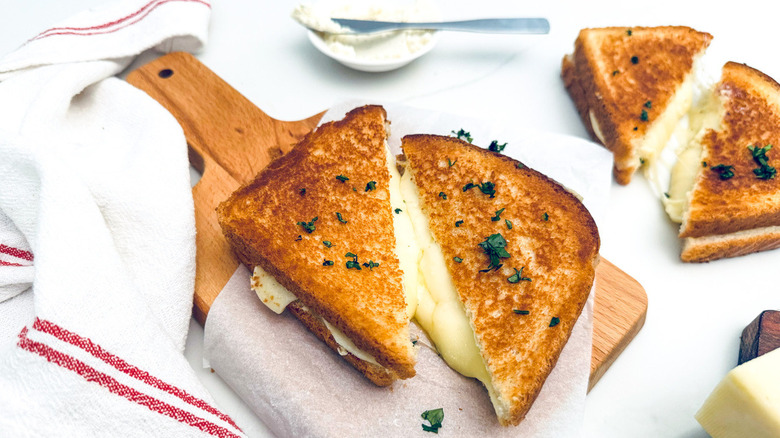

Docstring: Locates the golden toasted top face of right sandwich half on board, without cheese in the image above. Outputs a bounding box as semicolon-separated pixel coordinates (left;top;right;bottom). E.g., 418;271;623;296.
402;135;599;424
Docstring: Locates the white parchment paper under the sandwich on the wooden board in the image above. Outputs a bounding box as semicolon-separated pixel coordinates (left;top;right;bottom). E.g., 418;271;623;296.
204;101;612;437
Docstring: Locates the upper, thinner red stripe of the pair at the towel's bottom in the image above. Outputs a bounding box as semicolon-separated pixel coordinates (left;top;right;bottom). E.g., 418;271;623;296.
33;318;241;430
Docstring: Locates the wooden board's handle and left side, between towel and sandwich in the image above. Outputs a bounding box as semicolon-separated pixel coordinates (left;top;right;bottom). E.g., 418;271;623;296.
127;52;322;323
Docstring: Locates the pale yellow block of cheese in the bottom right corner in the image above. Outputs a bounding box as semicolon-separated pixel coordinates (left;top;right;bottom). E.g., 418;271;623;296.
696;349;780;438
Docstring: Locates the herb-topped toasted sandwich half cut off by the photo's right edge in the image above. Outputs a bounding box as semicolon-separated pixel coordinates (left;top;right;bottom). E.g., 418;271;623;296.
673;62;780;262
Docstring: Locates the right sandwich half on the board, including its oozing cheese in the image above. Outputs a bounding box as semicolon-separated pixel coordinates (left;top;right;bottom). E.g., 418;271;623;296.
401;135;599;425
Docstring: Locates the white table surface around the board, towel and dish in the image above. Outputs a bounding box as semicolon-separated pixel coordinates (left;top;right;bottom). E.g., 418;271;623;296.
6;0;780;438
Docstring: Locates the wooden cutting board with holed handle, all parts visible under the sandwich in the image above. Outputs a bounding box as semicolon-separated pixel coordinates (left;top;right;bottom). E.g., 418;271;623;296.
127;53;647;387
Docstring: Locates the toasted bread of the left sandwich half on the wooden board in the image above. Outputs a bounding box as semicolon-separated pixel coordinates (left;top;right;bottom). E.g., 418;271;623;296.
217;106;415;385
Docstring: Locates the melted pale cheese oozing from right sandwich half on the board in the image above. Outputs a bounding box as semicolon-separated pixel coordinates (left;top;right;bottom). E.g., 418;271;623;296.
401;169;494;399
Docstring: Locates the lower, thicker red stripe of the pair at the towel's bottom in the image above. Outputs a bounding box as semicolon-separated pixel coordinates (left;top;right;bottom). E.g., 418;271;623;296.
17;328;238;438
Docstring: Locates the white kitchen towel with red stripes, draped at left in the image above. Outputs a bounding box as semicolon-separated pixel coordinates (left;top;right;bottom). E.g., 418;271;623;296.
0;0;243;437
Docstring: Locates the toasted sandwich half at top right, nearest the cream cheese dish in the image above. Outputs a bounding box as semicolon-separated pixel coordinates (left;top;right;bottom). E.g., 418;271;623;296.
561;26;712;184
